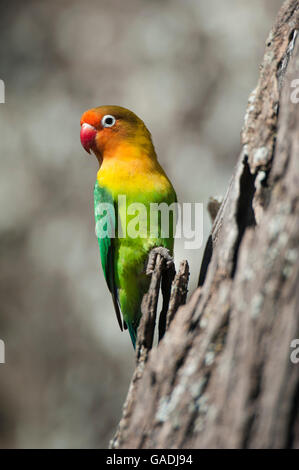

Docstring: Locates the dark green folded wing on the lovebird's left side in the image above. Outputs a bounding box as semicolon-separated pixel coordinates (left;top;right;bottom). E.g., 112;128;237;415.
94;182;123;330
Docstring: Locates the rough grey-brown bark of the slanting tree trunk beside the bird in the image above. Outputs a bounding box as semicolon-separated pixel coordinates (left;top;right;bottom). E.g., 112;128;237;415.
110;0;299;448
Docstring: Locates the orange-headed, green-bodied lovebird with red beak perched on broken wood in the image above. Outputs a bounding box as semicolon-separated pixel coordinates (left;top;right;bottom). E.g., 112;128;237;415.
80;106;177;348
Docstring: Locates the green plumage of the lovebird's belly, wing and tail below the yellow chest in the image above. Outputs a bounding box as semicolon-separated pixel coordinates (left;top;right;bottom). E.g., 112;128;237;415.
94;182;176;348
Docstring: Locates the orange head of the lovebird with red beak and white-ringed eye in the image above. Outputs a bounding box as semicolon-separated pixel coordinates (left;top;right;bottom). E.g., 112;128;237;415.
80;106;155;164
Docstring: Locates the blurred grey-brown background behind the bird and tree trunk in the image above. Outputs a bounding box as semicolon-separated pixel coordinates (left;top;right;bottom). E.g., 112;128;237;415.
0;0;282;448
